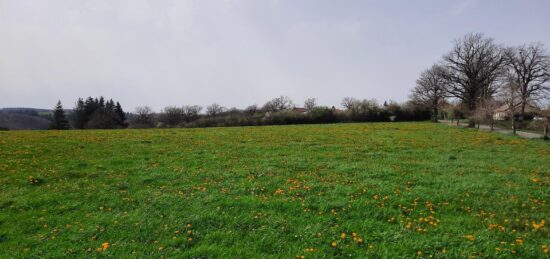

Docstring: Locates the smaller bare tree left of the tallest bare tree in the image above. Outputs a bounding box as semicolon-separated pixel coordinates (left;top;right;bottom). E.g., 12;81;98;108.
411;64;449;122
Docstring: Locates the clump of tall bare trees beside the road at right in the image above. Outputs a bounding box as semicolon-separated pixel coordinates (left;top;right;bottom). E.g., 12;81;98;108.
411;33;550;136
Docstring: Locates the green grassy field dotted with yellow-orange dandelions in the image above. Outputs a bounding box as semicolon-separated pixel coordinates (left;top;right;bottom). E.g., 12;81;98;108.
0;123;550;258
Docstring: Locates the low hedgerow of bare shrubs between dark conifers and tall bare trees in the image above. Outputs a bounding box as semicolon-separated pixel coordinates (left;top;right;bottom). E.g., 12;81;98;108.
128;96;430;128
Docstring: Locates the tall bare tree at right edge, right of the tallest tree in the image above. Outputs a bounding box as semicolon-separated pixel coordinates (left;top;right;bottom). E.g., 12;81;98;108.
506;43;550;120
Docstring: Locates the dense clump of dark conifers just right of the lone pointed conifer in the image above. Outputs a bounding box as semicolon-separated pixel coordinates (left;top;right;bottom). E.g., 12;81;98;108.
71;97;126;129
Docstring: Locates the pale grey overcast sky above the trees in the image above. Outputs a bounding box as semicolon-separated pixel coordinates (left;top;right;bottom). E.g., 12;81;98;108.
0;0;550;111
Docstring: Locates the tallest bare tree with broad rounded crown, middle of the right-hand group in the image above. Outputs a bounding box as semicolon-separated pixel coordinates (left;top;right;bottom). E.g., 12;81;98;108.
443;33;505;127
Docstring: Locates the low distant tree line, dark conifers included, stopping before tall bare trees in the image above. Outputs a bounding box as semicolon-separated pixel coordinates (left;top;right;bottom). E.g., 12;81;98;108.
50;96;430;129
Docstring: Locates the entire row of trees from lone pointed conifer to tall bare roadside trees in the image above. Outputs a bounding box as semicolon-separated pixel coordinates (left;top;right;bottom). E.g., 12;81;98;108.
51;33;550;139
